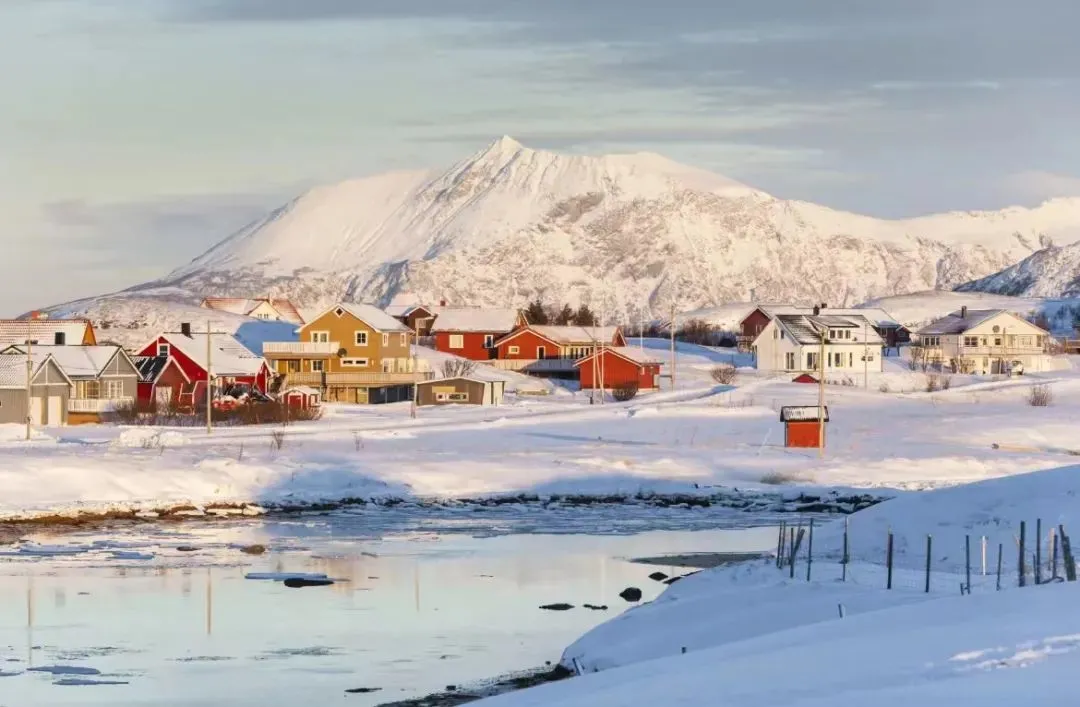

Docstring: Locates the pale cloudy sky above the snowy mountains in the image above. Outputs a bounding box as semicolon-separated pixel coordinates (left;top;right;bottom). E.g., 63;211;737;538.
0;0;1080;315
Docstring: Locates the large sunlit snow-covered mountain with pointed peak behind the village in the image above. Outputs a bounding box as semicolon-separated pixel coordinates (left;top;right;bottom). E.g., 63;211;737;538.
38;137;1080;321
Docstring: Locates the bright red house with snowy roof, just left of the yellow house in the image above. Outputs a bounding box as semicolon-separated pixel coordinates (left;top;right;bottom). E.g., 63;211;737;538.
138;324;270;404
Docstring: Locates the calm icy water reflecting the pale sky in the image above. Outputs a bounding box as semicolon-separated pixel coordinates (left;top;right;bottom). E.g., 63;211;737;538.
0;508;774;707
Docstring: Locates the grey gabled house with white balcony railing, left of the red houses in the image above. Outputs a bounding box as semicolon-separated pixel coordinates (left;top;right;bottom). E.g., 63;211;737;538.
0;344;140;424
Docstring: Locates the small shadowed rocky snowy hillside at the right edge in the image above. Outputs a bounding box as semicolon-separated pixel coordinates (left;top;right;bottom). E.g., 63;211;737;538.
957;243;1080;298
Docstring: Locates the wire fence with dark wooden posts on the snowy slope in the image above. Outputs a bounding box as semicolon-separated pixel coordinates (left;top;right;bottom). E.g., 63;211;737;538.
774;519;1077;594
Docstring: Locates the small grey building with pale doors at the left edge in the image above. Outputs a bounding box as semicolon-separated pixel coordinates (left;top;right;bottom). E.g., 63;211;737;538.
0;355;73;426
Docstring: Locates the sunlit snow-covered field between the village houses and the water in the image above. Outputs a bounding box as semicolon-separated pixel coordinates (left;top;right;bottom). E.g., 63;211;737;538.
0;340;1080;517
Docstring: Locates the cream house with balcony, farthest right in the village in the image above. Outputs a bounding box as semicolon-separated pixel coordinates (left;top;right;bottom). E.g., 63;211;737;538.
912;307;1052;375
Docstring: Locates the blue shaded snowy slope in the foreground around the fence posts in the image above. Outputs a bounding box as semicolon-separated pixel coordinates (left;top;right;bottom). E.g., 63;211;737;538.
483;466;1080;707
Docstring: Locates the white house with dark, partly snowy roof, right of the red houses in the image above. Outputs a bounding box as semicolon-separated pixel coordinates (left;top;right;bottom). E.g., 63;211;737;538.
752;314;882;375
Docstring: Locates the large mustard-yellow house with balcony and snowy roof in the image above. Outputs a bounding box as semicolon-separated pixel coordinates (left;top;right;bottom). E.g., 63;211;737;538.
262;302;431;403
